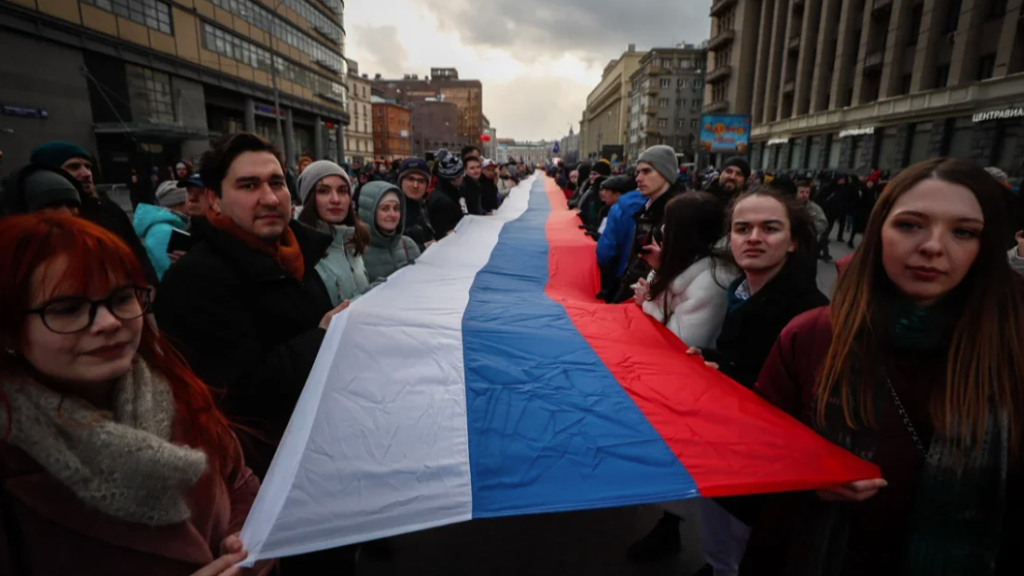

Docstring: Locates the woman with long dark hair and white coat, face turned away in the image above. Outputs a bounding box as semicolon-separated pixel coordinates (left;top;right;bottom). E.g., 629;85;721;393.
634;192;736;347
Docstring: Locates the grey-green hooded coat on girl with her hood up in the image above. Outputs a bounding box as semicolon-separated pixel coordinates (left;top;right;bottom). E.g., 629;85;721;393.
358;181;420;282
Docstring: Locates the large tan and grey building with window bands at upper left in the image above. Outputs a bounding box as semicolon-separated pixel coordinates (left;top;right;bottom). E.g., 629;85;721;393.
0;0;349;182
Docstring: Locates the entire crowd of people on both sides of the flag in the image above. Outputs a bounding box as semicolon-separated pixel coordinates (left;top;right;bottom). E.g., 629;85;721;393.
0;133;1024;576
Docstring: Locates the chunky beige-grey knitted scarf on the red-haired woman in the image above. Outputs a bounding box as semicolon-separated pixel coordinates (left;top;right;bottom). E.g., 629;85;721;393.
0;358;207;526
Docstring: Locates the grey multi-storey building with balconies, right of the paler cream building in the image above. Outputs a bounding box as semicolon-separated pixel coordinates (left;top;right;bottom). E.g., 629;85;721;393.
627;44;707;161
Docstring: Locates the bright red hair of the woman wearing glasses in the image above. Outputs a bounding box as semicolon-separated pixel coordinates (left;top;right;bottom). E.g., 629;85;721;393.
0;211;241;470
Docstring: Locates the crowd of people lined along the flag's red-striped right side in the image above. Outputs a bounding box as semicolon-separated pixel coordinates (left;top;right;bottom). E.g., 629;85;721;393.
549;146;1024;576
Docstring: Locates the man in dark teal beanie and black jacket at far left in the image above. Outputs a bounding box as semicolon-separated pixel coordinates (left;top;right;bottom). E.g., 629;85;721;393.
31;141;159;286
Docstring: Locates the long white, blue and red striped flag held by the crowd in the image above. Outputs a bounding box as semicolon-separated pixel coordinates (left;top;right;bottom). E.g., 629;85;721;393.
235;177;879;563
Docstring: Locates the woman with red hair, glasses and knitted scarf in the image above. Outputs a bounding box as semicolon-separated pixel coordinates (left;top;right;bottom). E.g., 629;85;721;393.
0;211;269;576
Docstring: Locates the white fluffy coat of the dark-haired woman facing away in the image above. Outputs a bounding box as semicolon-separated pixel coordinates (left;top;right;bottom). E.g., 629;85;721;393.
668;271;728;348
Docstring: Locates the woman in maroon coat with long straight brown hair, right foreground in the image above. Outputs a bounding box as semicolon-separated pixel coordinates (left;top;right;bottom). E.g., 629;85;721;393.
743;159;1024;576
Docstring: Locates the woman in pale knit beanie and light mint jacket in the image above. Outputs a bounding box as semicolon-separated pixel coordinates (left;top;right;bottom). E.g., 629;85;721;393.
297;160;371;306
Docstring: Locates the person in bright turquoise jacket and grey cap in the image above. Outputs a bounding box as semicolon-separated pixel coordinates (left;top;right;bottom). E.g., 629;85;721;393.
132;180;188;280
